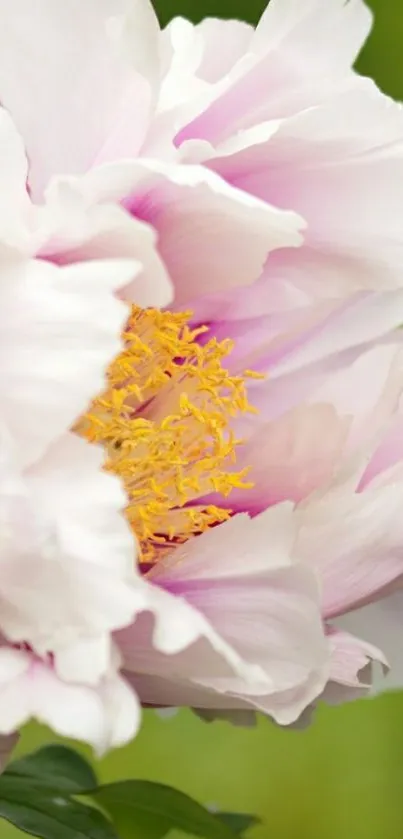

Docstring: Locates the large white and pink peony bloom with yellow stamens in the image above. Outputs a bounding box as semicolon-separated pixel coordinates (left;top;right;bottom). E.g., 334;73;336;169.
0;0;403;752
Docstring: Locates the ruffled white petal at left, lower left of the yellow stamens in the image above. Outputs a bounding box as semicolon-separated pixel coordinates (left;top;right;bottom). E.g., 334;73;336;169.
0;435;148;683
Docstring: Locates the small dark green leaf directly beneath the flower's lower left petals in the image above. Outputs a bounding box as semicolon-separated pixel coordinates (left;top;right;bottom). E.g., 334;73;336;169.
5;746;98;793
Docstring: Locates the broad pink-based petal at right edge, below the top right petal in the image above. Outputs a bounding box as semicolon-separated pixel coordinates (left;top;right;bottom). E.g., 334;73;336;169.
208;84;403;296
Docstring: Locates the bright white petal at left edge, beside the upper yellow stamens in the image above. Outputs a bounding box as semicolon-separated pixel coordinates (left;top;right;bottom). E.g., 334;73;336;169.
0;260;138;465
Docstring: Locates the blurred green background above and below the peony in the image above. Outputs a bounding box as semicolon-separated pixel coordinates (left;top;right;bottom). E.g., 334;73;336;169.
5;0;403;839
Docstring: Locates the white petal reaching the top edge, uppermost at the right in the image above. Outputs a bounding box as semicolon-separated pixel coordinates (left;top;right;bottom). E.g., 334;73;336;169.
175;0;371;145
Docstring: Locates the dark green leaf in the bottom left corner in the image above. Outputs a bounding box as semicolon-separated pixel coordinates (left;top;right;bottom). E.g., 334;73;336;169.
0;775;118;839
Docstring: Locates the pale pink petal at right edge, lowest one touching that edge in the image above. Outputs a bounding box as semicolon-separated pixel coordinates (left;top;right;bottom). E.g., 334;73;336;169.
295;462;403;617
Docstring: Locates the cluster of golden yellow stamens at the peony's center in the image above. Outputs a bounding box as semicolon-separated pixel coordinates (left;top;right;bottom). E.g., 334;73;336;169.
76;306;254;563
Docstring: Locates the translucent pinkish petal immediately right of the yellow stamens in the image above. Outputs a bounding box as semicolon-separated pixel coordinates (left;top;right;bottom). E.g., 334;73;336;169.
202;344;403;513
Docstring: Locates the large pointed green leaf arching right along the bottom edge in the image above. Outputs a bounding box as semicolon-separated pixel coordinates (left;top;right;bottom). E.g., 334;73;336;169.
87;781;237;839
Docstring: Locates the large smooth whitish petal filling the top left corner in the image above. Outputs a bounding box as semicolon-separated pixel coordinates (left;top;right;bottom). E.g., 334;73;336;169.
0;0;158;193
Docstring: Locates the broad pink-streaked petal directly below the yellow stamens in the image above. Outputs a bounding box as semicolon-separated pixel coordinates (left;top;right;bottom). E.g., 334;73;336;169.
118;505;327;723
